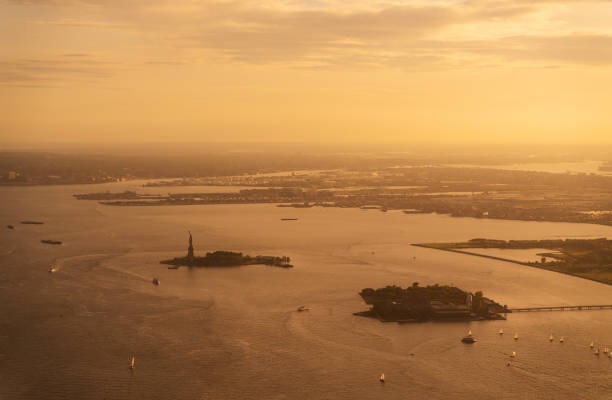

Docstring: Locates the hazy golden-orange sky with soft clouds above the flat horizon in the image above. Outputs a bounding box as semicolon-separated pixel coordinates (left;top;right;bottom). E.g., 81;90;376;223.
0;0;612;144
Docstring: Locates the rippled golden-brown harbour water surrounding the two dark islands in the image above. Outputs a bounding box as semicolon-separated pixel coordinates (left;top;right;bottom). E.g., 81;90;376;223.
0;183;612;399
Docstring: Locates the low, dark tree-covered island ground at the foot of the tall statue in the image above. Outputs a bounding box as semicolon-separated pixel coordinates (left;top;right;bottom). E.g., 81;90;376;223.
160;251;293;268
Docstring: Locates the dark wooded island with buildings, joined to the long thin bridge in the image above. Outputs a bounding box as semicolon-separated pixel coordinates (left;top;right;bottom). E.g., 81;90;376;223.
356;282;507;322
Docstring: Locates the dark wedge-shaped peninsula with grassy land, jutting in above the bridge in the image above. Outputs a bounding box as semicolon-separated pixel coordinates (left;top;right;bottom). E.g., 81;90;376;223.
418;238;612;284
